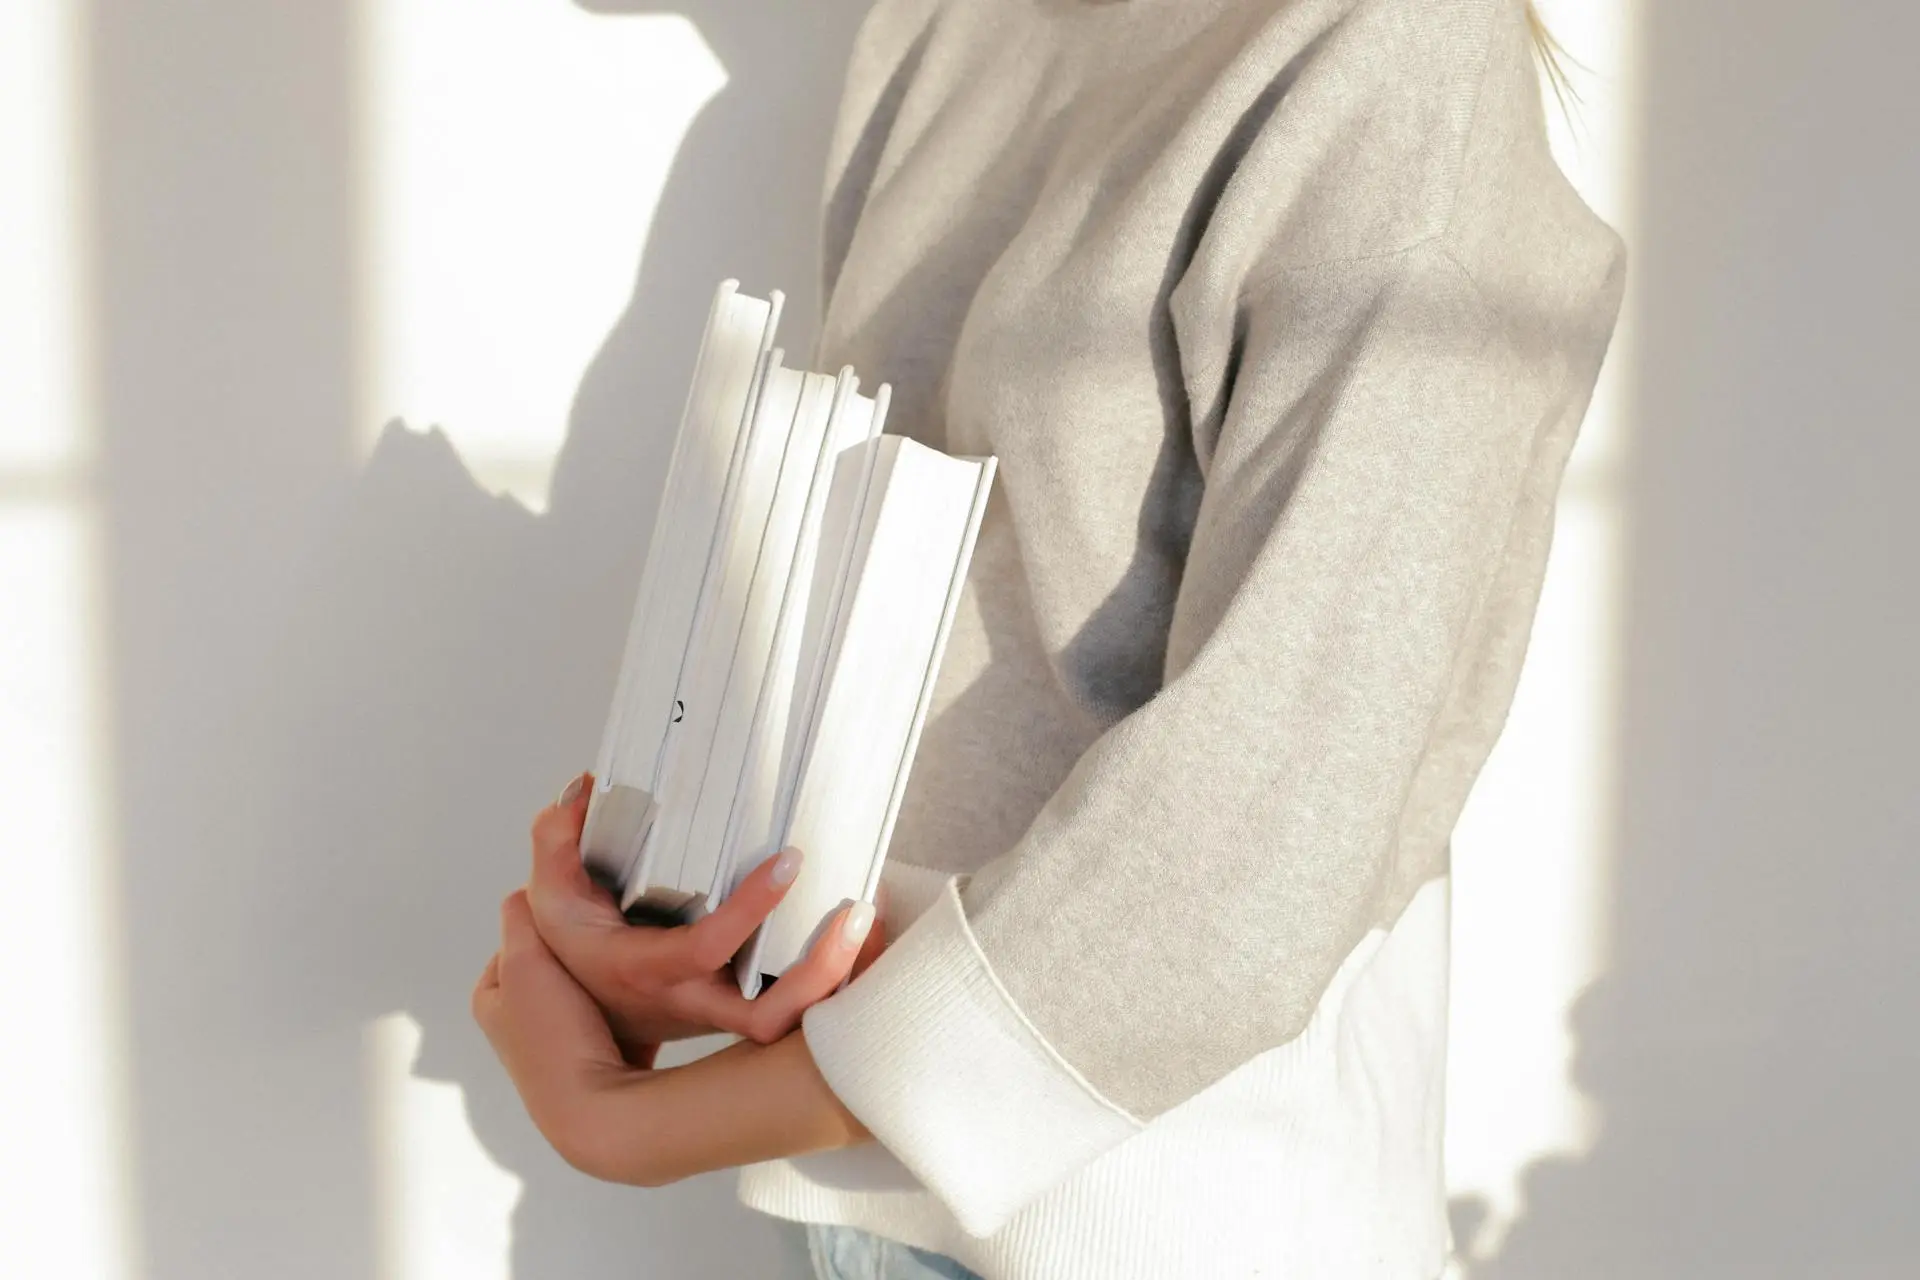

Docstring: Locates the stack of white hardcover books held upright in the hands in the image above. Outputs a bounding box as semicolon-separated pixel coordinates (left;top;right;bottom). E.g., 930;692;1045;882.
582;280;995;994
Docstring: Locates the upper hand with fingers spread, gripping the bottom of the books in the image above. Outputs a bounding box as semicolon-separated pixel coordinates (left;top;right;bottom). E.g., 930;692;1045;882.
528;773;885;1065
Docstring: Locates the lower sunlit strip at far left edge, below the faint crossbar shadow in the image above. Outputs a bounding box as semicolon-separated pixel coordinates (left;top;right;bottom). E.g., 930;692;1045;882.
0;506;134;1280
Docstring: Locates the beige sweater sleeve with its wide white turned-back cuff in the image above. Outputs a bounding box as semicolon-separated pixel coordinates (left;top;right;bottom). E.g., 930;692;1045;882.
804;242;1620;1234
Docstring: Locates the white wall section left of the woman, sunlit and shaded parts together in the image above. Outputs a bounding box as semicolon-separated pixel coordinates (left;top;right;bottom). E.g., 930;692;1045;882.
0;0;858;1280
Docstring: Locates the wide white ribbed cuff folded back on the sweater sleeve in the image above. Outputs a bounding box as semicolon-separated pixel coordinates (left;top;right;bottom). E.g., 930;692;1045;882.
801;879;1140;1236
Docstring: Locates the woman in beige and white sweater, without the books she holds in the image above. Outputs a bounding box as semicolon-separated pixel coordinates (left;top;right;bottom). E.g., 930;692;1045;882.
474;0;1624;1280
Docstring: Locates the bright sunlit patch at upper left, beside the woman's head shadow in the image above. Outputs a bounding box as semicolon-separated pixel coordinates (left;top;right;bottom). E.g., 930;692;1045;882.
357;0;726;510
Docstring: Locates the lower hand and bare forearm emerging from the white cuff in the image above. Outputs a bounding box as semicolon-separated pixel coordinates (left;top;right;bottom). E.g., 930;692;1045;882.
472;890;870;1186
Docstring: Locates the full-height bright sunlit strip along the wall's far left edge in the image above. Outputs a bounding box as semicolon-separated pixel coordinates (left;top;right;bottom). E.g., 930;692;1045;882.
0;0;134;1280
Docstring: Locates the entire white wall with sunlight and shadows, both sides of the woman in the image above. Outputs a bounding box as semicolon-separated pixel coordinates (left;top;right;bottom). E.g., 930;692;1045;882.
0;0;1920;1280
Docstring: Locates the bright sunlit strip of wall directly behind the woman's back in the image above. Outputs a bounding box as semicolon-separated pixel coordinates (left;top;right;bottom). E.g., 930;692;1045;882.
1446;0;1640;1261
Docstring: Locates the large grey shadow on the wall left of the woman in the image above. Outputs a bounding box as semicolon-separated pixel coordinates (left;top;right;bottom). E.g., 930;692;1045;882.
88;0;864;1280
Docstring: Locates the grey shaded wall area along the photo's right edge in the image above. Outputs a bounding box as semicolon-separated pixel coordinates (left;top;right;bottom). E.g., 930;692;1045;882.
1455;4;1920;1280
